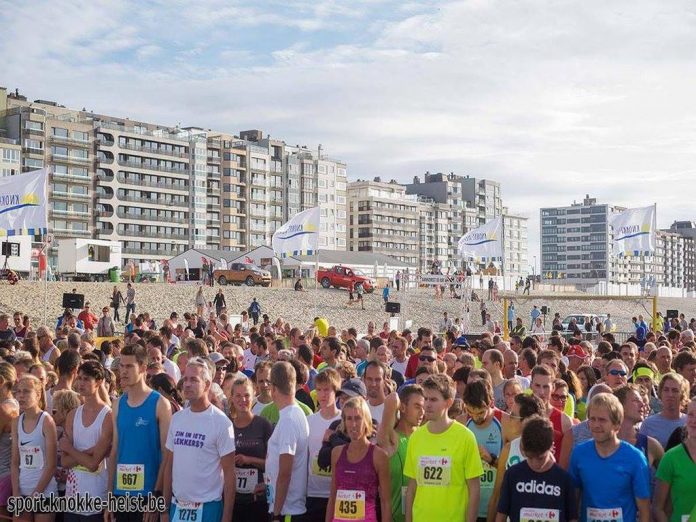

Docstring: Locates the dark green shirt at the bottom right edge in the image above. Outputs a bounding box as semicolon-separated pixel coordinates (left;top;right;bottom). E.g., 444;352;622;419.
656;444;696;522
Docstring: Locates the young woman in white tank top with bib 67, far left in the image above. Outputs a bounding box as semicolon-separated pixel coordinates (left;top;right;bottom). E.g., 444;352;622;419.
11;374;57;512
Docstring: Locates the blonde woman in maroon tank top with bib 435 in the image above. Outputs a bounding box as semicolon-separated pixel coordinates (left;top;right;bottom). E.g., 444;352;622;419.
326;397;391;522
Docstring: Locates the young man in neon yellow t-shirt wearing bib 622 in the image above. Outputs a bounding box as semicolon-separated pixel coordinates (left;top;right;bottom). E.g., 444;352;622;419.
404;374;483;522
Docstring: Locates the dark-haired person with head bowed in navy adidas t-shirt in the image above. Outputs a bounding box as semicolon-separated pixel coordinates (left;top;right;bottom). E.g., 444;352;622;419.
495;416;578;522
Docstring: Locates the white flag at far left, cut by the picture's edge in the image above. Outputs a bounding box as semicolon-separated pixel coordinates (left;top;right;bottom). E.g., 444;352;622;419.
0;169;48;237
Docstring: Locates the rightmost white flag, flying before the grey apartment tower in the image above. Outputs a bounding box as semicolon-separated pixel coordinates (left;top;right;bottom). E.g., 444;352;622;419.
609;205;655;256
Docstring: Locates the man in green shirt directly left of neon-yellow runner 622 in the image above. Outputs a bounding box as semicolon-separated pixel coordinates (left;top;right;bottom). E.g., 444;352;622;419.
377;384;425;522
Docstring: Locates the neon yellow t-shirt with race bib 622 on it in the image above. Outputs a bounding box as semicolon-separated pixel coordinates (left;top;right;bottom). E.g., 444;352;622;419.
404;422;483;522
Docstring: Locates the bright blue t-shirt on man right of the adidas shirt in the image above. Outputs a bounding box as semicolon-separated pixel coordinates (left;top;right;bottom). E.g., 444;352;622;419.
568;440;650;522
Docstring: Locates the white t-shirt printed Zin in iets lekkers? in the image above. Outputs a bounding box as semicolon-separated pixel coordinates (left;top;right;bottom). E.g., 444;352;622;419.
166;404;235;502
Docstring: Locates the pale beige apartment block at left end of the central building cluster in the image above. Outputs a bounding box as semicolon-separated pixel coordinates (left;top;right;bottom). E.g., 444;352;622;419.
348;178;421;267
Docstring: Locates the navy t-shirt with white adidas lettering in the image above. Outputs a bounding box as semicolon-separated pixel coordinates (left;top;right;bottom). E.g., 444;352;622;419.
498;461;578;522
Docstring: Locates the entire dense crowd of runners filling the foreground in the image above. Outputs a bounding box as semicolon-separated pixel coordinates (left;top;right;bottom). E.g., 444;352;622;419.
0;288;696;522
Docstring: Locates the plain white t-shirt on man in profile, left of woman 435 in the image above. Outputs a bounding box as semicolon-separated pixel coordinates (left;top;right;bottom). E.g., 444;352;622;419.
264;404;309;515
